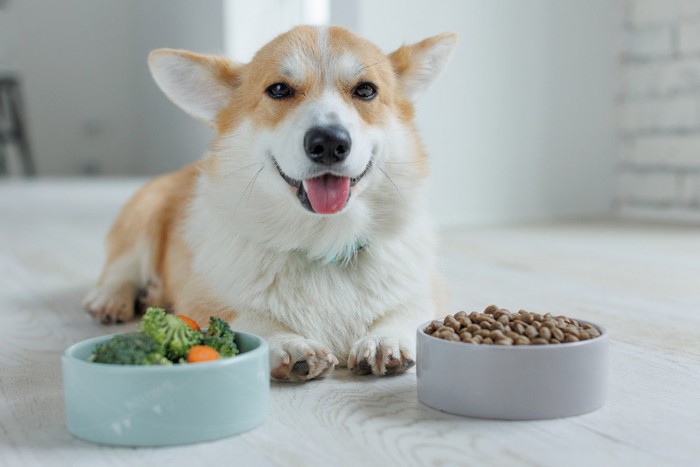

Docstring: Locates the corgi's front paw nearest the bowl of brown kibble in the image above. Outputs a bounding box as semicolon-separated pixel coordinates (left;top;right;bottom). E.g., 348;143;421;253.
348;336;416;376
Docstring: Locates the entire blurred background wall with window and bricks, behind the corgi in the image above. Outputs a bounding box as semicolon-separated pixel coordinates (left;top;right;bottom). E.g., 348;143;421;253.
0;0;700;226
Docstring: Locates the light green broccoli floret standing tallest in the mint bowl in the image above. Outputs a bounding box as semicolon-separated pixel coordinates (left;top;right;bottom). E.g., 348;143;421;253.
141;307;202;361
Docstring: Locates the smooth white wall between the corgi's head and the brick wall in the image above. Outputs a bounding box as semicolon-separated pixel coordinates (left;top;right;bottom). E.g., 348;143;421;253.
358;0;616;225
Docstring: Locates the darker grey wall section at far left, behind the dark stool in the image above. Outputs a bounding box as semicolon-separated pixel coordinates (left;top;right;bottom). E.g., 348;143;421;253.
0;0;136;174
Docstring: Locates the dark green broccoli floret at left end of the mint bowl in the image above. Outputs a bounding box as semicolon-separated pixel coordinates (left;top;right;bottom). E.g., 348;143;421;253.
88;333;172;365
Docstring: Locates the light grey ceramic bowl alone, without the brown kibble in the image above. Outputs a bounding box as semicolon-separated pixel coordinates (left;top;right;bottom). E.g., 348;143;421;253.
416;320;609;420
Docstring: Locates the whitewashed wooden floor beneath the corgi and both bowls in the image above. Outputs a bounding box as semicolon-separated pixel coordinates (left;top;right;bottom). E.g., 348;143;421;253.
0;180;700;467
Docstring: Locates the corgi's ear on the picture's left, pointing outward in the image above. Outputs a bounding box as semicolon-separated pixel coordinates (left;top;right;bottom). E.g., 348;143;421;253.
148;49;242;126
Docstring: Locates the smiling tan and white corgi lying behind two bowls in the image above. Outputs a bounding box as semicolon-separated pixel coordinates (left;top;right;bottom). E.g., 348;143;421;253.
85;26;456;381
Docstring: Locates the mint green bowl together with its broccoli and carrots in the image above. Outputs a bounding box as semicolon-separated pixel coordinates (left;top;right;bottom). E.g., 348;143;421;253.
62;308;270;446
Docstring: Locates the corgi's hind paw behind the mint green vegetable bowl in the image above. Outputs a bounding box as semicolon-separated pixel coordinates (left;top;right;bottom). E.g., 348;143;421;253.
83;284;136;324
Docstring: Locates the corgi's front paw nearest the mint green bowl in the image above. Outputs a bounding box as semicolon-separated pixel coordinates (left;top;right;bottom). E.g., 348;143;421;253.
270;337;338;381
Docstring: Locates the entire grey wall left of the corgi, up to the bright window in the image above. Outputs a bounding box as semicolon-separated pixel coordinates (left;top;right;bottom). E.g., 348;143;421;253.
0;0;223;175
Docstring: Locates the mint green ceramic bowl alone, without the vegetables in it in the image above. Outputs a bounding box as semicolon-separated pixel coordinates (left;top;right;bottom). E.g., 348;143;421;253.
62;332;270;446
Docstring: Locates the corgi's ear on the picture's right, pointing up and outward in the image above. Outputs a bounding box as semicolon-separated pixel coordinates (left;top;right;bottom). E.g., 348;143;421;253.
389;32;457;100
